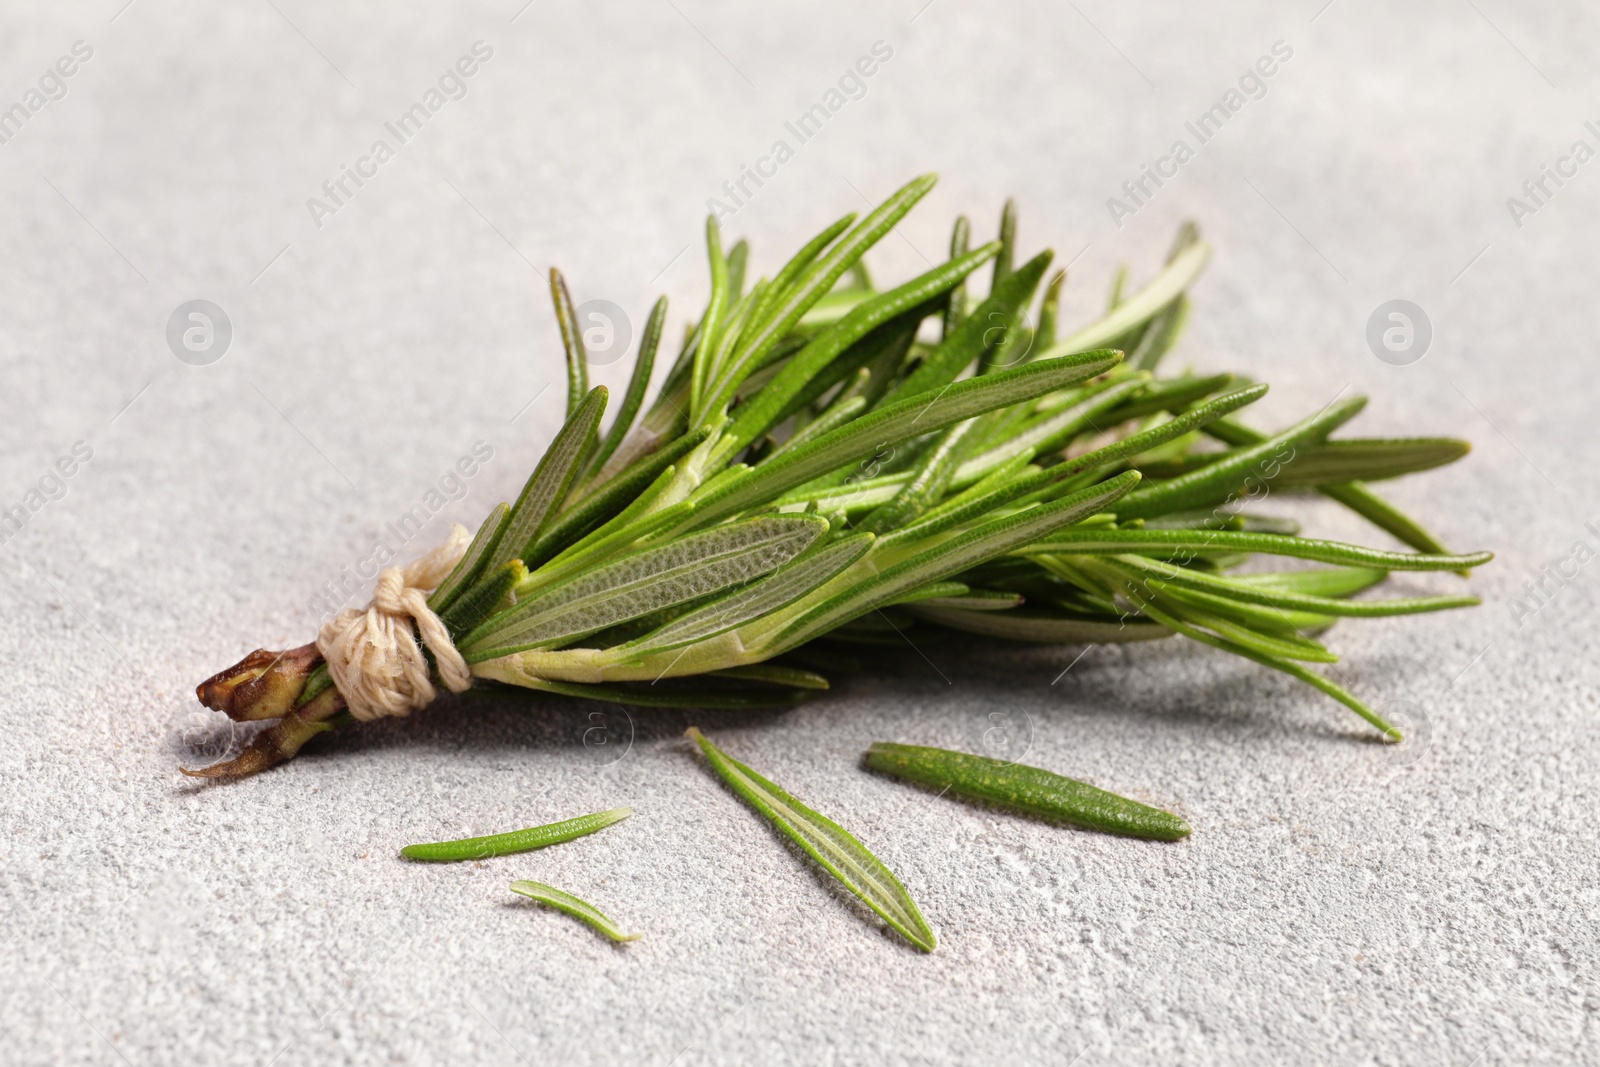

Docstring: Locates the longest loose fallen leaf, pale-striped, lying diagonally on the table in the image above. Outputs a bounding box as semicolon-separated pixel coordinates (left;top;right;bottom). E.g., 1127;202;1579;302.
688;726;938;952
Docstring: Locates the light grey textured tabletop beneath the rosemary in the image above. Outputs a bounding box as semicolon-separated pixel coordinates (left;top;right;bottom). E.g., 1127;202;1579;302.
0;0;1600;1067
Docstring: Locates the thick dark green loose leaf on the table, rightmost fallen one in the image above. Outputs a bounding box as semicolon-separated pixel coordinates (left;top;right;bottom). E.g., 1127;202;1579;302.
866;741;1190;841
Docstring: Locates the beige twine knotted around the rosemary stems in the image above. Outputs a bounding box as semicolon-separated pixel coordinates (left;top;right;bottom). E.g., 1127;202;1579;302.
317;523;472;721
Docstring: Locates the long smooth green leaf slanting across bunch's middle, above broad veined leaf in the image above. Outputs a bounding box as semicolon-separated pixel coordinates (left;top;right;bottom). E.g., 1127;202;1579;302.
694;352;1120;525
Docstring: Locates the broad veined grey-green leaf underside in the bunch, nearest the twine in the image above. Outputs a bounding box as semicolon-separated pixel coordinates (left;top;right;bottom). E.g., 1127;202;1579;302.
459;515;827;662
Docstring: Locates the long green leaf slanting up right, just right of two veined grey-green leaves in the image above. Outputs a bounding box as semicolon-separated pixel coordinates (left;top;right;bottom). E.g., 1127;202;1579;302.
771;470;1139;651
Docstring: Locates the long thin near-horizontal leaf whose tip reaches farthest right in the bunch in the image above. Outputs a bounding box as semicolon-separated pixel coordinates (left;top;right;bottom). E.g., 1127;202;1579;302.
1019;530;1494;571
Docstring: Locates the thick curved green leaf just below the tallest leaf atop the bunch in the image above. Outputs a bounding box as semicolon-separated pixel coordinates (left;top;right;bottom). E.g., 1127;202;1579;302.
717;245;998;456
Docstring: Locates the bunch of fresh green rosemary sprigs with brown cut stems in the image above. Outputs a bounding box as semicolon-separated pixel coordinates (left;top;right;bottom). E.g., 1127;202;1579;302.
190;176;1490;777
